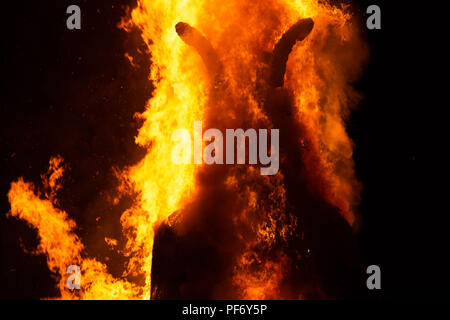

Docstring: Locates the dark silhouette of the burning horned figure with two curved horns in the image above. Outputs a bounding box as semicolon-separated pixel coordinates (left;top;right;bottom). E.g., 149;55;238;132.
152;5;368;299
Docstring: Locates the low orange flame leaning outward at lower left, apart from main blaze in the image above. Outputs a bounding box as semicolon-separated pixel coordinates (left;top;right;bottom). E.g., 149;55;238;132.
8;157;140;300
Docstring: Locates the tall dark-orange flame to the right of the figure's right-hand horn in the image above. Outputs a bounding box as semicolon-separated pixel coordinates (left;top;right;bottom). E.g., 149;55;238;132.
287;5;368;225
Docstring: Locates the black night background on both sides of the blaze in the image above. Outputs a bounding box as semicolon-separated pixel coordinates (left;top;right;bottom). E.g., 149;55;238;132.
0;0;442;299
